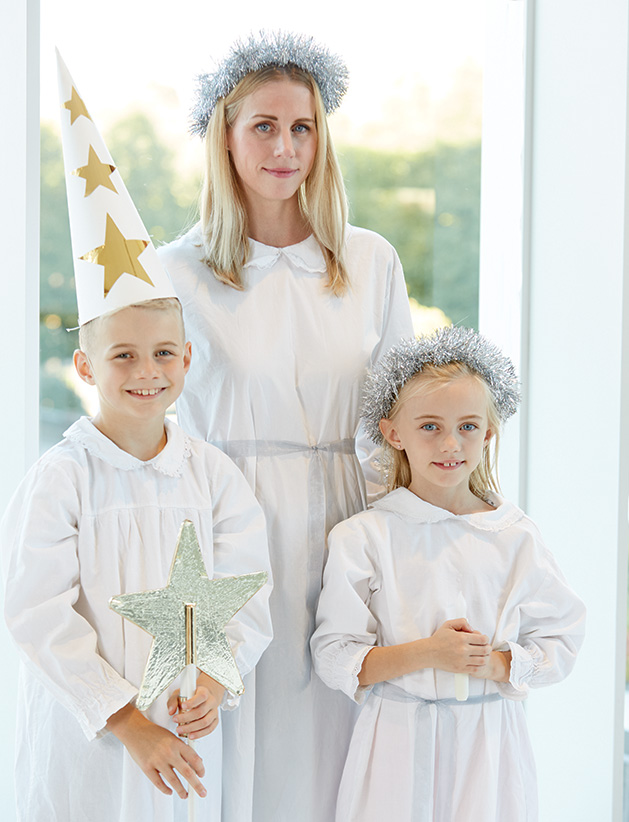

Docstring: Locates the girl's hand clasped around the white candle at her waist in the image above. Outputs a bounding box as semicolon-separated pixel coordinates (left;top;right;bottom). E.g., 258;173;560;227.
419;619;491;676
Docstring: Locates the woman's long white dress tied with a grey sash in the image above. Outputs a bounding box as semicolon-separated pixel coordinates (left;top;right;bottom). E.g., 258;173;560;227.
160;222;413;822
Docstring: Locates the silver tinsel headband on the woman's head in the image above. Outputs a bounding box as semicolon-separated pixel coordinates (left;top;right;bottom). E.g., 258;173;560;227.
190;31;349;137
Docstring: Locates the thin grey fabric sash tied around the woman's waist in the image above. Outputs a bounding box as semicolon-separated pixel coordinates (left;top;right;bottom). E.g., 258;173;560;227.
212;437;364;680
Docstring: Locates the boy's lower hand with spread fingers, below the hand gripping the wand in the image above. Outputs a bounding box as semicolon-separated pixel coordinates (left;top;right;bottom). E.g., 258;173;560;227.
107;704;207;799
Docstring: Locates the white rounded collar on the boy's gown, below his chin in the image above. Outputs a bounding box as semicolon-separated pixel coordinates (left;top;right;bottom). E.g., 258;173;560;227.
63;417;192;477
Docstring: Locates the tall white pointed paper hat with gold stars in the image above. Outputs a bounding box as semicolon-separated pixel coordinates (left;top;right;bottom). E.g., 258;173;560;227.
57;52;177;325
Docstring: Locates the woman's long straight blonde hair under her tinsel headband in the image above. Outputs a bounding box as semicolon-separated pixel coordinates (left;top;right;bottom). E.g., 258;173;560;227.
200;66;348;296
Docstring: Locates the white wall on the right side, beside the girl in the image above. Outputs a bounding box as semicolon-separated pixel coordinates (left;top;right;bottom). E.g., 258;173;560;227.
481;0;629;822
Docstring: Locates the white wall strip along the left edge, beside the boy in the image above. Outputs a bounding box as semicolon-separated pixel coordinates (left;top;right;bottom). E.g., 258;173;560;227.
0;0;39;822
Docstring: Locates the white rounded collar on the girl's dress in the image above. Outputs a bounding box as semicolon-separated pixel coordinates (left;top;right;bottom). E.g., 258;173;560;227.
371;488;524;531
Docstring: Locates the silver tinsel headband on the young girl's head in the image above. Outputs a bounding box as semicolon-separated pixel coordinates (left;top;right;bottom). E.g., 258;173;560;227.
361;326;520;445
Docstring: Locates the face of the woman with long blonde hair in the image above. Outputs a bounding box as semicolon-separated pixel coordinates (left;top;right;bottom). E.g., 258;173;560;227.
227;78;317;208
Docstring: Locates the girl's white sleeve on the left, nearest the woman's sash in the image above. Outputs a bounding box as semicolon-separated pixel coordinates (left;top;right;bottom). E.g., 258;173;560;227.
311;521;379;703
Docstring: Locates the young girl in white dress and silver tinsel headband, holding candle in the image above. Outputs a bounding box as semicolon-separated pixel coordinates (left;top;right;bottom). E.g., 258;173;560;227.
312;328;584;822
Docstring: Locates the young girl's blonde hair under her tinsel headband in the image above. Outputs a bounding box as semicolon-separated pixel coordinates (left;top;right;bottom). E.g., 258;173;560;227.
381;362;500;499
